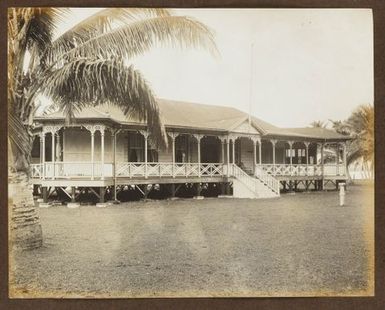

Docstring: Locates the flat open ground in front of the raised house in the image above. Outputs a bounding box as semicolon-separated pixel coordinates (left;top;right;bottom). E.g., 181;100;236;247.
10;184;374;297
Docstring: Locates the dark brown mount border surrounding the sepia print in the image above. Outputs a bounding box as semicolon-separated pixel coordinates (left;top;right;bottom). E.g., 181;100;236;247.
0;0;385;309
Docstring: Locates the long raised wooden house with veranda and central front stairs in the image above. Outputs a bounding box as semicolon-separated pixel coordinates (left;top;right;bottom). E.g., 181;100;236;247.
31;100;349;202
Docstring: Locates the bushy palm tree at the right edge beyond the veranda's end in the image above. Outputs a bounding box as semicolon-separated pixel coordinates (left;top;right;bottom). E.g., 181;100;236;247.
333;104;374;178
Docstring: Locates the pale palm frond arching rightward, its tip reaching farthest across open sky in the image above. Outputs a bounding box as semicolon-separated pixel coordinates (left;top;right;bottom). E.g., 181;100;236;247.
53;16;218;65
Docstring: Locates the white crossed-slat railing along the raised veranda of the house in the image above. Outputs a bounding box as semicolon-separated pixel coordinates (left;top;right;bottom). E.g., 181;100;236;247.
31;162;346;180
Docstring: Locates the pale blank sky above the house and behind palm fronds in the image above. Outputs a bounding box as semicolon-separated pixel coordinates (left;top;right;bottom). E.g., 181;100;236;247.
53;8;374;127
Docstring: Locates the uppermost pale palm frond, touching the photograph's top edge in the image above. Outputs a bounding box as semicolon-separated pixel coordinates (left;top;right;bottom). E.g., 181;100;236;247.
44;8;171;63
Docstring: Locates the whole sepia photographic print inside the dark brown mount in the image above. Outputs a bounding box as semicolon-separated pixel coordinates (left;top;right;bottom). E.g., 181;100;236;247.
7;7;375;298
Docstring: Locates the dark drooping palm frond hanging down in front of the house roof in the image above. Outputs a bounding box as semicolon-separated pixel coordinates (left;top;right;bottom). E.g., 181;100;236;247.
41;59;167;147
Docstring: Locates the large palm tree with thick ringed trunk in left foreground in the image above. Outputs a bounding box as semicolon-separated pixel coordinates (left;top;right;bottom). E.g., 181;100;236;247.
8;8;216;248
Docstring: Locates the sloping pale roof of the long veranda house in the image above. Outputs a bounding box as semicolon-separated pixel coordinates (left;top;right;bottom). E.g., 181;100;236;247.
35;99;348;140
